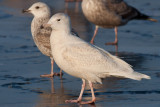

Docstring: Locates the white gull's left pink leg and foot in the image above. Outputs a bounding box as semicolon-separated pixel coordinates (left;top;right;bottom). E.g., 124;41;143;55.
65;79;86;103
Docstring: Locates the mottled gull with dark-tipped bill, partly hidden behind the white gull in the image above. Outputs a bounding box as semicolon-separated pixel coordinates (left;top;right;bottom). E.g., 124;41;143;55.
23;2;77;77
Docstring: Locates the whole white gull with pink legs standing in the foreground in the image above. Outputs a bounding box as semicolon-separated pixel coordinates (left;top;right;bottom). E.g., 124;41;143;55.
44;13;150;104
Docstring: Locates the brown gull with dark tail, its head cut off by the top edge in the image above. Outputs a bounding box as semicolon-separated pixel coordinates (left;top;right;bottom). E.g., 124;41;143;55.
82;0;157;45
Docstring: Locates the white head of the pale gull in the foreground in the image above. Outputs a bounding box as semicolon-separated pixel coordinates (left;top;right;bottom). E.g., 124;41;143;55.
46;13;71;32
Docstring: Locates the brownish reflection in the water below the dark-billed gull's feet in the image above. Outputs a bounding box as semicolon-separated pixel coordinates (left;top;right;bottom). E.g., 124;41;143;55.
36;78;96;107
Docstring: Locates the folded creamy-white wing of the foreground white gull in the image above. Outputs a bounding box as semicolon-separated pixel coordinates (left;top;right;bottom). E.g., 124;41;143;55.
63;43;133;73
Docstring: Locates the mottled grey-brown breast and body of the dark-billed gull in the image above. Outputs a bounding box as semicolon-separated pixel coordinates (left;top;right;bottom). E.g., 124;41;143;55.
31;18;52;57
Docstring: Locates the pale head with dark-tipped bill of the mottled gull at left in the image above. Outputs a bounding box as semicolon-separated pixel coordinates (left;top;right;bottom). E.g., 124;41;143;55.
22;2;50;17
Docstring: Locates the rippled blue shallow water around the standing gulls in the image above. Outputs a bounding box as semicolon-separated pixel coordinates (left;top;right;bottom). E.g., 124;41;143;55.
0;0;160;107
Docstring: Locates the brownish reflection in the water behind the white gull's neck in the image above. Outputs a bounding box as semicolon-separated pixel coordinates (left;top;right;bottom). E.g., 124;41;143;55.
64;1;92;41
